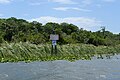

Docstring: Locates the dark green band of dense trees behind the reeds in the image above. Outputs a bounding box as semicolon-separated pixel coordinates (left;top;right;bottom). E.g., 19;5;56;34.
0;17;120;46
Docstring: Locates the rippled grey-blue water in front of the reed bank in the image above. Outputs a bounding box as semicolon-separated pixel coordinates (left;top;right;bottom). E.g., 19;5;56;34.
0;55;120;80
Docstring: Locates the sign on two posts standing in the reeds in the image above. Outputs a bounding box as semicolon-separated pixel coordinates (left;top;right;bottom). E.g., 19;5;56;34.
50;34;59;54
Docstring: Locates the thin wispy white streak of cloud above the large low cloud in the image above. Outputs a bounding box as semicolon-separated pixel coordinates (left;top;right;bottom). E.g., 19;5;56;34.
53;7;91;12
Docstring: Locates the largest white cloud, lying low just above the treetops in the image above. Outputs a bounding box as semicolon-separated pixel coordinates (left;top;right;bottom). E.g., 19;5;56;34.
29;16;101;30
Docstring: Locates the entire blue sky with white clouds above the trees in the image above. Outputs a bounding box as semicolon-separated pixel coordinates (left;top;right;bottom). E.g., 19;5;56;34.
0;0;120;33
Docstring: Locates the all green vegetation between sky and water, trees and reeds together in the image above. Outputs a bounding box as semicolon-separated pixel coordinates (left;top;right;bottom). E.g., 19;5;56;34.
0;17;120;62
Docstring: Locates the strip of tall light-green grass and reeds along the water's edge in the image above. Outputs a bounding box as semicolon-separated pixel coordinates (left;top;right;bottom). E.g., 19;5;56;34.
0;42;120;62
